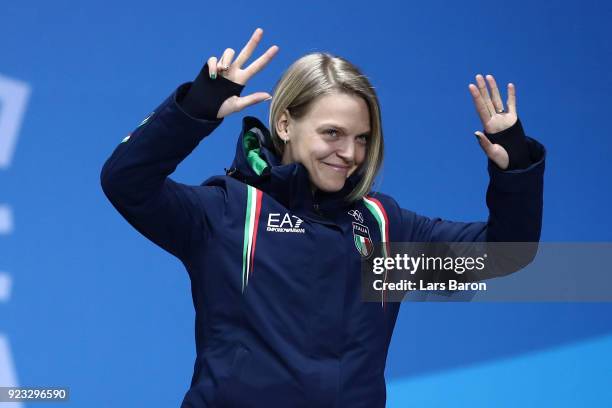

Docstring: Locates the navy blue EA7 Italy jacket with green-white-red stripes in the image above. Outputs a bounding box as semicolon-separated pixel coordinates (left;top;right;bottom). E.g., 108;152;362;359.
101;83;545;408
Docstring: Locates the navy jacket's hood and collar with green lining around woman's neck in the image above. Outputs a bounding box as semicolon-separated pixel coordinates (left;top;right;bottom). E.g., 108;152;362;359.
226;116;362;210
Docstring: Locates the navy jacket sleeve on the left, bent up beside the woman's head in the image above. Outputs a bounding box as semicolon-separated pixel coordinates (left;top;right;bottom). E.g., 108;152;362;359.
100;83;223;260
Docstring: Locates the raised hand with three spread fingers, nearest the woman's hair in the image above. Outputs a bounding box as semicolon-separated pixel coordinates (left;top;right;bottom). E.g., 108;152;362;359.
208;28;279;119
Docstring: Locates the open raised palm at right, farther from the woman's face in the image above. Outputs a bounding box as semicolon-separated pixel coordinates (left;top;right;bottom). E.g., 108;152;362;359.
469;74;517;170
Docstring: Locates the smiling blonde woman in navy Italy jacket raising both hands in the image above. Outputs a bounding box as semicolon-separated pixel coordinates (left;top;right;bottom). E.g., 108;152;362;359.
101;29;544;407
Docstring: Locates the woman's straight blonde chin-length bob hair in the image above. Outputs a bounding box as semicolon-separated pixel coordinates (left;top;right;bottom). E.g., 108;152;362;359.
268;52;384;202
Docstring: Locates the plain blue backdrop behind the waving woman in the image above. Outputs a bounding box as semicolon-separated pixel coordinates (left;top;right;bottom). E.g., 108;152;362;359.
0;0;612;408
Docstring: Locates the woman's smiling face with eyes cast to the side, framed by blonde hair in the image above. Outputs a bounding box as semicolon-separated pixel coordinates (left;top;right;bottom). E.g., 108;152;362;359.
277;92;370;192
